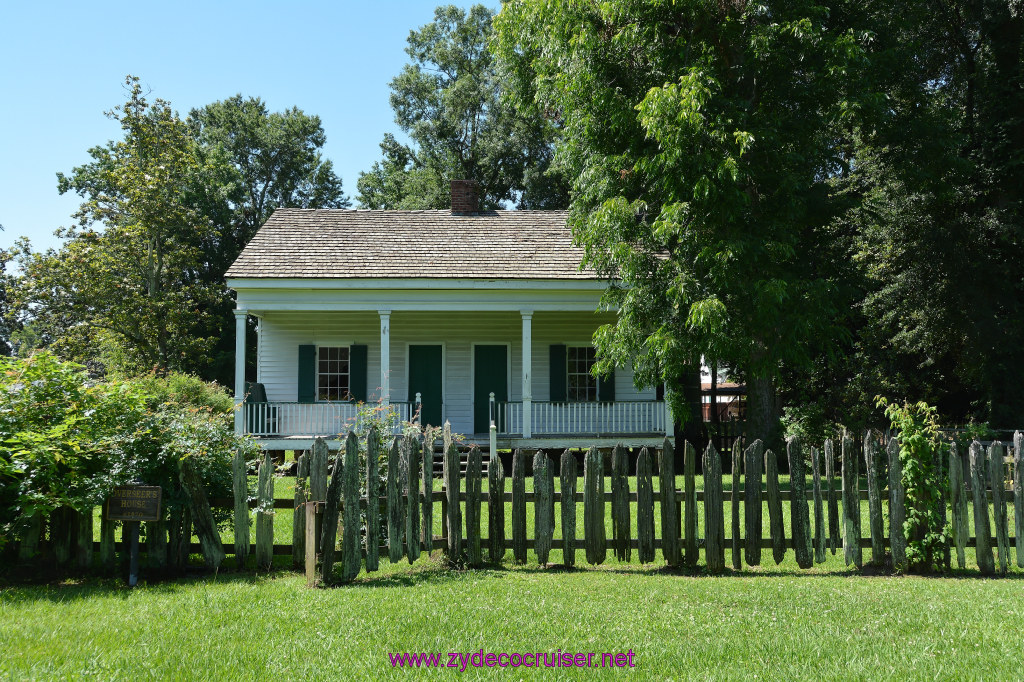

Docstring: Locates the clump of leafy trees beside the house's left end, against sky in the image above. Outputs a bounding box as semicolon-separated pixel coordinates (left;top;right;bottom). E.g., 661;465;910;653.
17;77;349;383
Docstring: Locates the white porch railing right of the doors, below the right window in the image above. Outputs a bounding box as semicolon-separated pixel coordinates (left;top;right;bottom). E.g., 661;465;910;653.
531;400;665;435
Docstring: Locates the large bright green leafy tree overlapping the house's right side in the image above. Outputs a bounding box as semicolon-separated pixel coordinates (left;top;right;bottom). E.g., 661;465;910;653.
496;0;863;443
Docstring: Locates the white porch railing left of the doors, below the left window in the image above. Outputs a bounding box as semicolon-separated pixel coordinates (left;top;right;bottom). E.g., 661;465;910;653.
243;402;416;436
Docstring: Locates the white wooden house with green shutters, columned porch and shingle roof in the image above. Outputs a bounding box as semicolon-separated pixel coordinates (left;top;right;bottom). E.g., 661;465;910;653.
227;181;672;450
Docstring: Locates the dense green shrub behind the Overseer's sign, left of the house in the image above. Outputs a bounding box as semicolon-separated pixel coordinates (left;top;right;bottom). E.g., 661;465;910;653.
0;351;256;545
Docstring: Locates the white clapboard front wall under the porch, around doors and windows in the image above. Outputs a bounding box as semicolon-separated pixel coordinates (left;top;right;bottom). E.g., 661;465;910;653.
257;311;654;433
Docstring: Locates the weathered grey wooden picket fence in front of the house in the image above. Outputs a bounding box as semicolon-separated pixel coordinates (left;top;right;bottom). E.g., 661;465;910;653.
251;425;1024;585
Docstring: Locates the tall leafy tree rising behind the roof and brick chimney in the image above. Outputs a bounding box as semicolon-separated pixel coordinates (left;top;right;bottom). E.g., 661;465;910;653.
357;5;567;209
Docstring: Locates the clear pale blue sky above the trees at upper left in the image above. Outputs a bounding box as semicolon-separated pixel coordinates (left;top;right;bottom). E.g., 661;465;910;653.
0;0;487;249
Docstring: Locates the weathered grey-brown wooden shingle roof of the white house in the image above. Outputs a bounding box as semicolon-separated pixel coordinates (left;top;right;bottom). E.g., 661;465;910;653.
220;209;598;280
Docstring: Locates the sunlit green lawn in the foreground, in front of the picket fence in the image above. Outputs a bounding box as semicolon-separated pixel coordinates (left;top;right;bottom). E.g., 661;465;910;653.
0;558;1024;680
